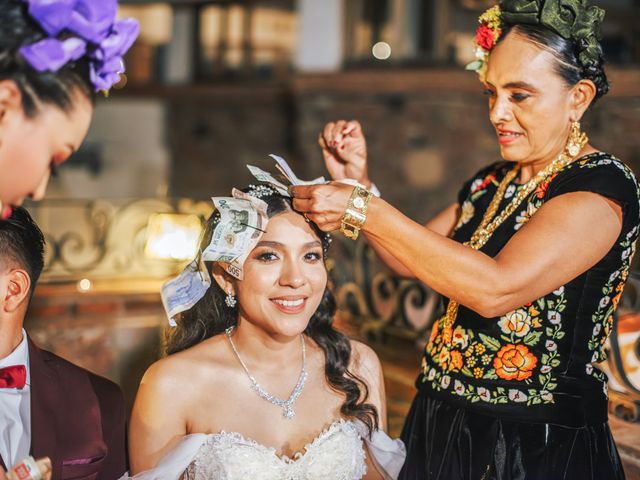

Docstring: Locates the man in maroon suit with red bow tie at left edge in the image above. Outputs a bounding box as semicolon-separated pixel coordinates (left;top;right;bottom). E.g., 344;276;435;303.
0;208;126;480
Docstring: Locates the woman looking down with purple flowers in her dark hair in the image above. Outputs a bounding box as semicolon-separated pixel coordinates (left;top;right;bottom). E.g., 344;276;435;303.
0;0;138;218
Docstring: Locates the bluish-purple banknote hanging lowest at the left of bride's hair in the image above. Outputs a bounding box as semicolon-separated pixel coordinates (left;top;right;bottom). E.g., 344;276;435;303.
160;255;211;327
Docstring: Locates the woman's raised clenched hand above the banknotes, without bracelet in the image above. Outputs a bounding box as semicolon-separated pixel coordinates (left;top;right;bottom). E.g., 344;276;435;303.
318;120;371;188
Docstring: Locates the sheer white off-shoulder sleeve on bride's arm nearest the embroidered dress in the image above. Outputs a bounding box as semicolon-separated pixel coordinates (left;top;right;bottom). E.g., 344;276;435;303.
356;421;407;480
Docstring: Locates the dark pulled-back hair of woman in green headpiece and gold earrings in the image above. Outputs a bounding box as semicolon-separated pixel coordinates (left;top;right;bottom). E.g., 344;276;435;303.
501;23;609;103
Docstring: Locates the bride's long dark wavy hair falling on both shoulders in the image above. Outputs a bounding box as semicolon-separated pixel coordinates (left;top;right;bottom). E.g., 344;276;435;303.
166;188;378;433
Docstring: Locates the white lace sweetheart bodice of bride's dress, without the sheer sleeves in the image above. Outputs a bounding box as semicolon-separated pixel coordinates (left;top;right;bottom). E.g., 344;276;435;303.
184;420;366;480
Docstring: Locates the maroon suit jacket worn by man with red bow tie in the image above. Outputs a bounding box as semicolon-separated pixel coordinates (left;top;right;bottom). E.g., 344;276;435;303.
0;339;126;480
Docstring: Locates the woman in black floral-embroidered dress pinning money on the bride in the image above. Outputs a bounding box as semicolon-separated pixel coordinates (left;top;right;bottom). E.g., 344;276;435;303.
292;0;639;480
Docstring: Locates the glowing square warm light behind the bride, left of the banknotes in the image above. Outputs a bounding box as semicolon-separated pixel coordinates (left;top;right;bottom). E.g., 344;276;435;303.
145;213;202;260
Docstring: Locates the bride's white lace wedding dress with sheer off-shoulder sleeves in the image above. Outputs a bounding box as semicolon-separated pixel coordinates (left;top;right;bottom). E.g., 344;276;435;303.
121;420;406;480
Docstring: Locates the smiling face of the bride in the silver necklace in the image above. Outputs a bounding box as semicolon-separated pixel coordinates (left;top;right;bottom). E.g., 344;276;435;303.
236;211;327;336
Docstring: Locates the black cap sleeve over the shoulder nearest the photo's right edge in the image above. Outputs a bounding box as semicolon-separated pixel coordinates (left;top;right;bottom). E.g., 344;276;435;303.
545;153;640;233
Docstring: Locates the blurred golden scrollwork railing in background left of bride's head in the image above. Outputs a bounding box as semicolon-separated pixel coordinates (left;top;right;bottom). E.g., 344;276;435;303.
29;199;213;282
